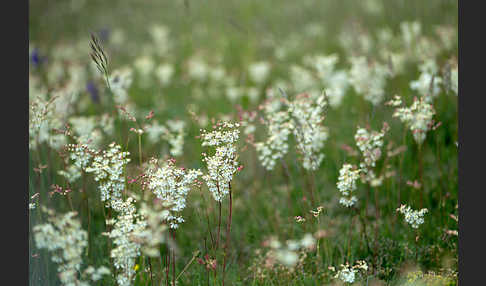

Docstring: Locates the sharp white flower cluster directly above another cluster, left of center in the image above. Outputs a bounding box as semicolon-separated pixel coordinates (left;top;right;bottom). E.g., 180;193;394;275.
85;143;130;211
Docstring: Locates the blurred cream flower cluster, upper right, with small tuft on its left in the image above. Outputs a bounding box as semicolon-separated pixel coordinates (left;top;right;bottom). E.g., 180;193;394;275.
388;96;435;145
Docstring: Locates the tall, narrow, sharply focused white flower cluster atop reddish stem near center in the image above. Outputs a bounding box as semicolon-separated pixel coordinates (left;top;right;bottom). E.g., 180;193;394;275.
201;121;240;202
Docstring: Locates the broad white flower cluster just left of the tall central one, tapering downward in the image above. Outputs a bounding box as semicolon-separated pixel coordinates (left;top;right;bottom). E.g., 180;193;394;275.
146;156;202;228
